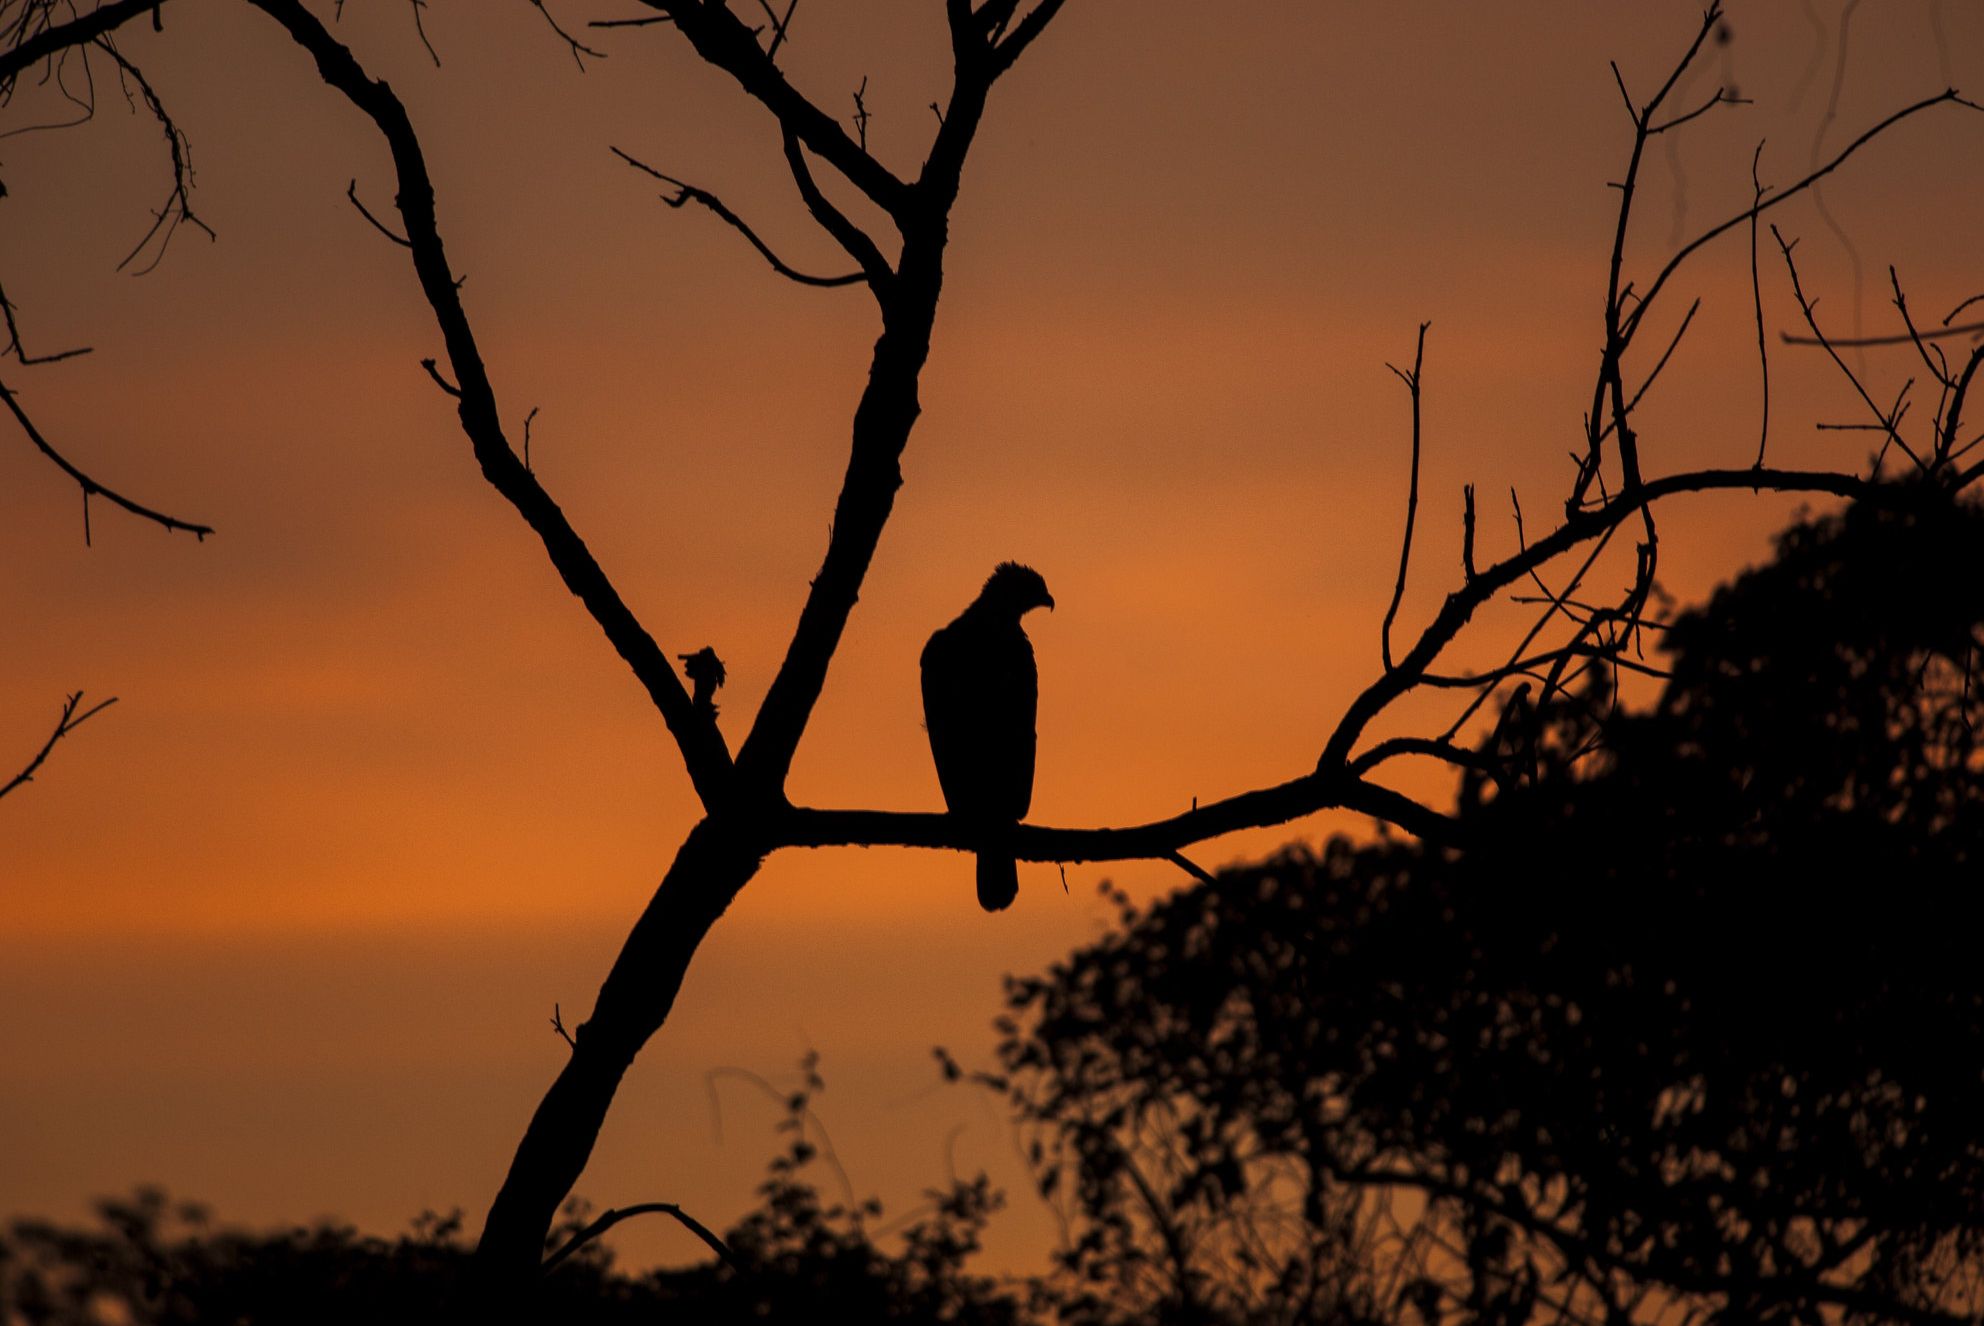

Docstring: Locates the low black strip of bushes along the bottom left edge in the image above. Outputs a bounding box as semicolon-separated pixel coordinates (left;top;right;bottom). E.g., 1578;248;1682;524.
0;1064;1030;1326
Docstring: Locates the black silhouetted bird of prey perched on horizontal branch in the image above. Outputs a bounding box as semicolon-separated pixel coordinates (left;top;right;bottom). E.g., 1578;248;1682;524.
923;562;1054;911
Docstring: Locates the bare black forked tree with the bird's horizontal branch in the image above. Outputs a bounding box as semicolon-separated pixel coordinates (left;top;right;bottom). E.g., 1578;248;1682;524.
0;0;1984;1302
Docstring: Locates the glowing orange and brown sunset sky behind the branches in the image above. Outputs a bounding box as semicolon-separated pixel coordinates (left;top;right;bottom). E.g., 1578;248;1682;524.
0;0;1984;1266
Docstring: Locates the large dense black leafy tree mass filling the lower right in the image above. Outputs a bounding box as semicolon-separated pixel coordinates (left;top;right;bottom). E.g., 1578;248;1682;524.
992;486;1984;1322
